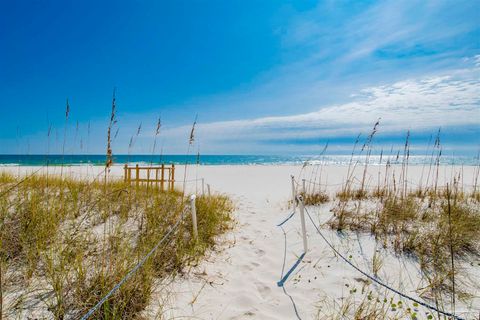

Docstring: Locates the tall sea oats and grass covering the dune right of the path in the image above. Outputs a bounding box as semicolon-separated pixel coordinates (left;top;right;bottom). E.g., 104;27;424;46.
299;124;480;319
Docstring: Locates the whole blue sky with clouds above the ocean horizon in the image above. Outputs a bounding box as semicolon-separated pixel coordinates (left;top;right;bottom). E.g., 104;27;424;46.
0;0;480;154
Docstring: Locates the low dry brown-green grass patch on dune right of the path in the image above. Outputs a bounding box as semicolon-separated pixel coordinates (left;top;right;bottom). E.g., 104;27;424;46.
329;185;480;298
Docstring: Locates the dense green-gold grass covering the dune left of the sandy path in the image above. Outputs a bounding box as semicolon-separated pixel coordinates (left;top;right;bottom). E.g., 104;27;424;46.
0;174;232;319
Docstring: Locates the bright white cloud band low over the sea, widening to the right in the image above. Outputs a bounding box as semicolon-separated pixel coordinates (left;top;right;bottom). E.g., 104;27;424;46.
155;63;480;152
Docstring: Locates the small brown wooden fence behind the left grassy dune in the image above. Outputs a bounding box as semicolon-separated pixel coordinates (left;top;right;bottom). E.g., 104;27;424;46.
123;164;175;190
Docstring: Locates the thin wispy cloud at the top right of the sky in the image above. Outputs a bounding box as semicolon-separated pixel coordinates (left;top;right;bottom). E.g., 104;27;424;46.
284;1;479;63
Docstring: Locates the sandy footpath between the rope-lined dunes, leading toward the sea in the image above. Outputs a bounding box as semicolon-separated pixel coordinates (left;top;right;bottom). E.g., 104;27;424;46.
163;167;297;319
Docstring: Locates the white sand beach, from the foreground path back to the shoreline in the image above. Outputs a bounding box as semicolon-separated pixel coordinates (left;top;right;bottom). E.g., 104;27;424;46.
0;165;480;319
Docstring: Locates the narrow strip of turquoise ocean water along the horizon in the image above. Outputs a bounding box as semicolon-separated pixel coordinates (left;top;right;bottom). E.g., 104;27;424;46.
0;154;480;166
